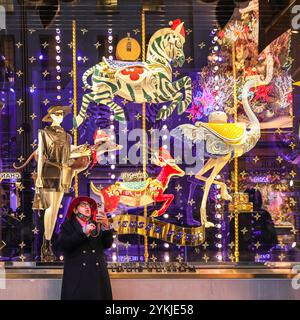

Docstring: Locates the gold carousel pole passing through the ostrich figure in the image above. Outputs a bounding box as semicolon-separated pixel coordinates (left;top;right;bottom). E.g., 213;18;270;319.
232;42;239;262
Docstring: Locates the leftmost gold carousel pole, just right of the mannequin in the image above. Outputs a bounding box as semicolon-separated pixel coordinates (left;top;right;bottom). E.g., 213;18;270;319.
72;20;79;197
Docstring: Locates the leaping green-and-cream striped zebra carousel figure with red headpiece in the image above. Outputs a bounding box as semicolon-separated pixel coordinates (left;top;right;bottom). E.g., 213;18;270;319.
73;19;192;128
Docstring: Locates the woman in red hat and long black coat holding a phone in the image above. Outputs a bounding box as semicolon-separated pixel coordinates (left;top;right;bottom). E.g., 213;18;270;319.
58;197;113;300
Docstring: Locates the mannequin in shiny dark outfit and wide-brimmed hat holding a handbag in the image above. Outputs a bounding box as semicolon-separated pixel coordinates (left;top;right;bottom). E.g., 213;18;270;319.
33;106;72;262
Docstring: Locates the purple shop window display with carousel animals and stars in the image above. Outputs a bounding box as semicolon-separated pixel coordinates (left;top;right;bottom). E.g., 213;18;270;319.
0;1;300;269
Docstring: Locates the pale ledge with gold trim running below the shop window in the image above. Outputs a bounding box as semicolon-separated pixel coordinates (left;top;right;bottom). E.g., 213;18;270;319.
0;263;300;300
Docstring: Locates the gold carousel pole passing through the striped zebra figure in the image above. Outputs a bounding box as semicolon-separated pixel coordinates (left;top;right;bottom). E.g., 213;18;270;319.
142;10;149;262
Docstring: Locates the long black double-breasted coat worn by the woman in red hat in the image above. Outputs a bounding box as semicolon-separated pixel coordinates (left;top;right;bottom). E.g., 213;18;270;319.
57;215;113;300
